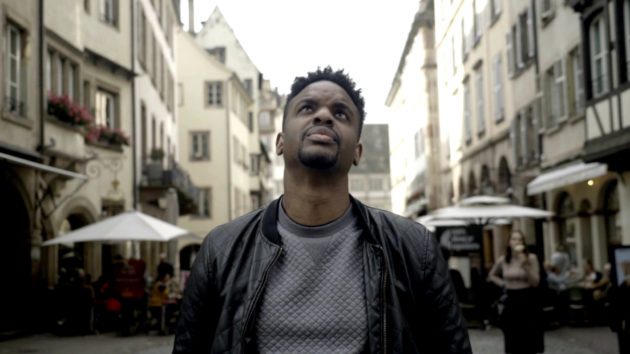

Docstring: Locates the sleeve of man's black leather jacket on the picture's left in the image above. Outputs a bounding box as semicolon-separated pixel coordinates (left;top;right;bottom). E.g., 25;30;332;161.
173;235;218;353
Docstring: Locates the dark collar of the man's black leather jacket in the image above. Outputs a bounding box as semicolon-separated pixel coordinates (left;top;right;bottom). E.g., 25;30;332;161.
262;195;378;245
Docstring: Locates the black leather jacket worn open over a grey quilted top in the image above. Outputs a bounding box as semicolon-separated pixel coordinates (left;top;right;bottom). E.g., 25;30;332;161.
173;198;471;354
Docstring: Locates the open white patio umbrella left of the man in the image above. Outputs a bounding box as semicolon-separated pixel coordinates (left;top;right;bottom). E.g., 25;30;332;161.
42;211;190;246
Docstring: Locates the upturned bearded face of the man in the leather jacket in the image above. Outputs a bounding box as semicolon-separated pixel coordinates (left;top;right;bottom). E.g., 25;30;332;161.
276;81;363;173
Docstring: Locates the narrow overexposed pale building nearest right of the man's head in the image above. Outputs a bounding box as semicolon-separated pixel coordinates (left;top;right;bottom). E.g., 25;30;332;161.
386;1;442;218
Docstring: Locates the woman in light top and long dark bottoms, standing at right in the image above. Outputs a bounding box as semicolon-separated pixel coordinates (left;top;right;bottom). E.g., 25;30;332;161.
488;230;544;354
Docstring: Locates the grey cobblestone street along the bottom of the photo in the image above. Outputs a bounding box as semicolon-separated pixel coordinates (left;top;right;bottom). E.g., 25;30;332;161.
0;327;618;354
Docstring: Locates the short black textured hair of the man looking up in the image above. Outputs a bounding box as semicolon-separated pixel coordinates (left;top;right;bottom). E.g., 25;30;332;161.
282;66;365;137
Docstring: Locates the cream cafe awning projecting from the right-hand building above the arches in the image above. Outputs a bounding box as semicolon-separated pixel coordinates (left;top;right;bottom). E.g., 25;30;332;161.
527;162;608;195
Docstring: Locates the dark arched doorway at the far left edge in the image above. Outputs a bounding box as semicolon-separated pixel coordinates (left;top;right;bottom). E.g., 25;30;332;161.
0;174;33;332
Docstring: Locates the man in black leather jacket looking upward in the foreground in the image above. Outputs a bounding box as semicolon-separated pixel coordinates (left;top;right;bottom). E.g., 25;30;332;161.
174;67;471;353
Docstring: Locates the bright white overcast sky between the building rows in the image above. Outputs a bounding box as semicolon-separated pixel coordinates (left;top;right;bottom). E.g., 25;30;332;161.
181;0;419;123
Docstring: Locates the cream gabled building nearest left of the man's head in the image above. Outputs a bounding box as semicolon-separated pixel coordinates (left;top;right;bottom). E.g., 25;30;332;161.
177;31;253;235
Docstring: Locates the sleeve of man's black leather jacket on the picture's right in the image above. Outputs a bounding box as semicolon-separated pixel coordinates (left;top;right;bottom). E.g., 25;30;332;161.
418;229;472;353
